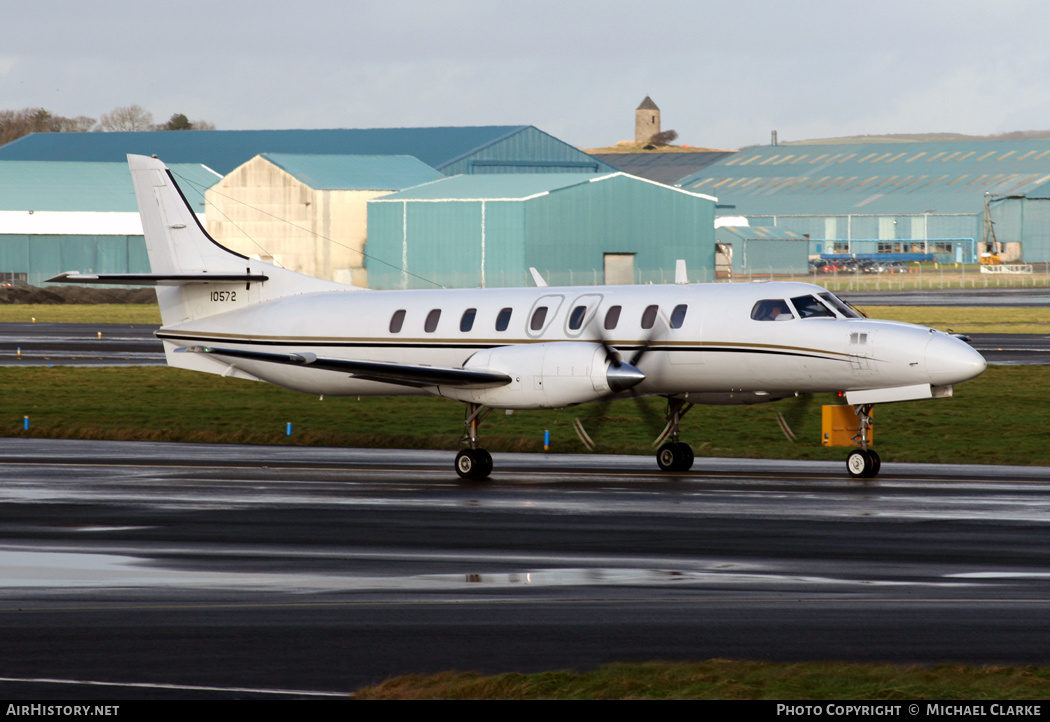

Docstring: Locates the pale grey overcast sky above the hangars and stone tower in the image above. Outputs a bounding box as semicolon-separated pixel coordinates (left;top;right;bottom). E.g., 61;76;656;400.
0;0;1050;148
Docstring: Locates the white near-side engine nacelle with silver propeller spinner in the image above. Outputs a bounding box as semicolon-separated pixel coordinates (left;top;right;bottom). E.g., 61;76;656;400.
439;341;645;408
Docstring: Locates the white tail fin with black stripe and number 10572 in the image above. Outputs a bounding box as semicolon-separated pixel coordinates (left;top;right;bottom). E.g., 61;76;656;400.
128;155;350;325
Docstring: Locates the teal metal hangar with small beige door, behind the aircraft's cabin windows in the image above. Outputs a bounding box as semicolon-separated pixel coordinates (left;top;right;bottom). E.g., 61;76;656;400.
365;173;715;289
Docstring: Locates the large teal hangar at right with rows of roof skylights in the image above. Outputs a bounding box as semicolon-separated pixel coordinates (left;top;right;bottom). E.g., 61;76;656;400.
676;141;1050;262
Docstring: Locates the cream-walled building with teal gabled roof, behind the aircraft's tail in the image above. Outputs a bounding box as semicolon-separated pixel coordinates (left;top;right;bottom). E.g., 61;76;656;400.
205;153;444;285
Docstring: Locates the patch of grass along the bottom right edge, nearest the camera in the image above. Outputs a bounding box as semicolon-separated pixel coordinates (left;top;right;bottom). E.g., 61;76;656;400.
355;660;1050;701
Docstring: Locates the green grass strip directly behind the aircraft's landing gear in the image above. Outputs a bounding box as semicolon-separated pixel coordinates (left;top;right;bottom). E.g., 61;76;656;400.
0;366;1050;468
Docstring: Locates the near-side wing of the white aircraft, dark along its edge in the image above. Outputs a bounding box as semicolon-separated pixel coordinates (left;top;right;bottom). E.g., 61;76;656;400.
175;346;511;388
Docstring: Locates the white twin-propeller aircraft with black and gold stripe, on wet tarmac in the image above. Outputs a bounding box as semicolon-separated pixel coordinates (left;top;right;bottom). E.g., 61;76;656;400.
50;155;985;479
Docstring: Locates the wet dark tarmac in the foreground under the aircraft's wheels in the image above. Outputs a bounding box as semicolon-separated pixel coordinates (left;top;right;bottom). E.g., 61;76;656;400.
0;439;1050;699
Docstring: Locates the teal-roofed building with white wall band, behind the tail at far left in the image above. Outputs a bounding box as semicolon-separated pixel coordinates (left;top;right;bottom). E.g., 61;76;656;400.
0;162;219;285
